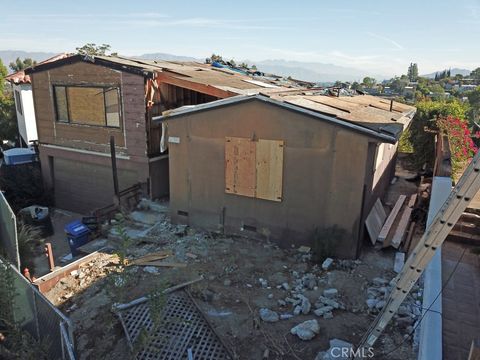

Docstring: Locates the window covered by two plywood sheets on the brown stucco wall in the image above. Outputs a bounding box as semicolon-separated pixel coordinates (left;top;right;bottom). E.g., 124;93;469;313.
225;137;283;201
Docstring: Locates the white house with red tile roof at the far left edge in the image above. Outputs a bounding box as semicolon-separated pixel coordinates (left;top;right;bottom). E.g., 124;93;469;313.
5;54;67;146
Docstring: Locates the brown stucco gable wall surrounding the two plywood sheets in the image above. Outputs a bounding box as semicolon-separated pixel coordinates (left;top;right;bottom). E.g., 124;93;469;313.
168;102;371;257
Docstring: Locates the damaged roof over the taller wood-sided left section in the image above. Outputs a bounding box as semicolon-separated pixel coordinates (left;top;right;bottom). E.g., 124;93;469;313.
26;54;299;96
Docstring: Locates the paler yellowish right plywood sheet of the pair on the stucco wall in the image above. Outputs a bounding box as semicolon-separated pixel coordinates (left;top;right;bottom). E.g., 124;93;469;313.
256;140;283;201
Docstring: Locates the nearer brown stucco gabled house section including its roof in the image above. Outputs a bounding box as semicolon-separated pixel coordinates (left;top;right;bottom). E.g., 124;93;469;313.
153;91;415;257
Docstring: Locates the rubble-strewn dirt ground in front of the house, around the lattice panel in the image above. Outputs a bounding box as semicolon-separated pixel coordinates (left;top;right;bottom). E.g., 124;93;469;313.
41;156;421;360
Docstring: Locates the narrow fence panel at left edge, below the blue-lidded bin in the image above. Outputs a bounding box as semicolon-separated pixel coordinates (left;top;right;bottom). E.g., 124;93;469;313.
0;191;20;269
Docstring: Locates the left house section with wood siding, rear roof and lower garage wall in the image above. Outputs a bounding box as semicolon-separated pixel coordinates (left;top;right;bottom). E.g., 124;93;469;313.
26;55;284;213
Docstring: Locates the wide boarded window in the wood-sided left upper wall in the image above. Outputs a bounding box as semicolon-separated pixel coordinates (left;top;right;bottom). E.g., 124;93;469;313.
54;86;121;127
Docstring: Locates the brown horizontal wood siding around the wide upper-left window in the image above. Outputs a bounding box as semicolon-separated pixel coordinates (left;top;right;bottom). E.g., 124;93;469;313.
32;62;147;160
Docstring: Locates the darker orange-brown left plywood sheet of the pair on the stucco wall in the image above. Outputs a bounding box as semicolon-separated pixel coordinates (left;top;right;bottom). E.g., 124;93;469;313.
225;137;256;197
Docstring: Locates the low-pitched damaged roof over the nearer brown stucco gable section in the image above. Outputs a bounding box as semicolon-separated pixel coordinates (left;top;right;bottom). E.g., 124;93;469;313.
153;89;416;144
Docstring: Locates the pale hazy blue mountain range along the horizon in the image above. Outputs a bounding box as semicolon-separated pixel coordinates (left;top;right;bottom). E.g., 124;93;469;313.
0;50;470;83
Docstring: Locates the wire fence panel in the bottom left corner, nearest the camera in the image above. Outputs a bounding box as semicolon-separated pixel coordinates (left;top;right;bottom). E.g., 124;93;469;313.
0;260;75;360
